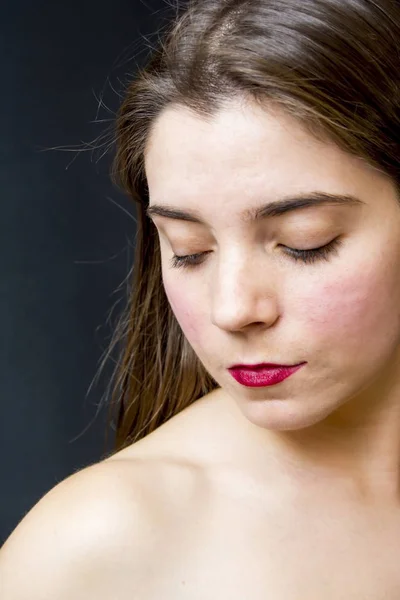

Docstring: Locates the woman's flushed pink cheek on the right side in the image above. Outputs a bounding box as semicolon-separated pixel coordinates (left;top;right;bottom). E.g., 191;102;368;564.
293;263;400;362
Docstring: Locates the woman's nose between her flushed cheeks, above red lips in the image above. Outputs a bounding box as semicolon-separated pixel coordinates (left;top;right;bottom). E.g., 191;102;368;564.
211;251;279;331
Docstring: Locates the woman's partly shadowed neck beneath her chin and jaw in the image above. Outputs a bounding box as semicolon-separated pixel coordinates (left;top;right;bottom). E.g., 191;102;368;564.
217;370;400;505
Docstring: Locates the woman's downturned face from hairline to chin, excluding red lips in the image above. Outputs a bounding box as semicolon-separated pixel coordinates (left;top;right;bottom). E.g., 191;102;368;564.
145;99;400;430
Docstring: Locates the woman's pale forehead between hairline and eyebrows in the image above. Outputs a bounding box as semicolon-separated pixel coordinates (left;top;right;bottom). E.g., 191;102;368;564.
145;103;390;218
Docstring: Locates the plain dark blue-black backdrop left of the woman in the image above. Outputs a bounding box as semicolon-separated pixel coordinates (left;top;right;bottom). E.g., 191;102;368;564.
0;0;173;544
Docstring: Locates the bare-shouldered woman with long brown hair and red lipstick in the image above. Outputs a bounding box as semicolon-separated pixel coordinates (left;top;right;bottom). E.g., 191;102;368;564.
0;0;400;600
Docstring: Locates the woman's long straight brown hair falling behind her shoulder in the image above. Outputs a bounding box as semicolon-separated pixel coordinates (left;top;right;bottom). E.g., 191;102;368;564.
101;0;400;452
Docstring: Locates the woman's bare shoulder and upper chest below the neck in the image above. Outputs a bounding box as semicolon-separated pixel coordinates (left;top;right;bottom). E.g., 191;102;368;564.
0;389;400;600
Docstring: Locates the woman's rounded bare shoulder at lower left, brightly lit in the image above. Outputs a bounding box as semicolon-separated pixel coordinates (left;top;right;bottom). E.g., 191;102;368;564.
0;459;180;600
